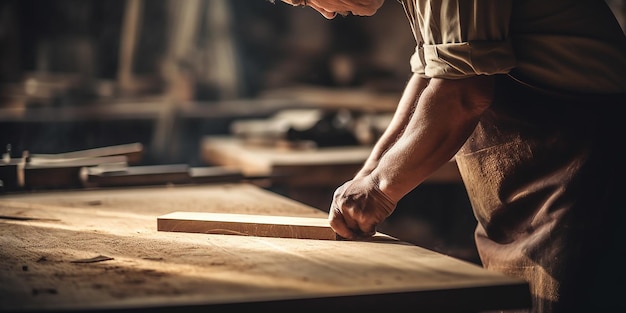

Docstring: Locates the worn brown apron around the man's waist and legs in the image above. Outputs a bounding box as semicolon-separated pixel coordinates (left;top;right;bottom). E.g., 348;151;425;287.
456;75;626;313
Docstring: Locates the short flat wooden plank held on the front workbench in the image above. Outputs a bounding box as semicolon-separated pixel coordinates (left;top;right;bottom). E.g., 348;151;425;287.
157;212;336;240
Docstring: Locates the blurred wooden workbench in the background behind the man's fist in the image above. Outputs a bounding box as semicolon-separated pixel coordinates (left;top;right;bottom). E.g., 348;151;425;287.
200;136;462;210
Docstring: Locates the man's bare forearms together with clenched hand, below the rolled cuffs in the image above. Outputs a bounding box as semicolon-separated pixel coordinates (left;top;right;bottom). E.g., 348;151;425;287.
329;76;494;239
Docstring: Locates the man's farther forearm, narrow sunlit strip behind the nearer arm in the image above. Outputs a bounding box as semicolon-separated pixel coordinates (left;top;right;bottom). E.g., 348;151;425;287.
356;74;428;177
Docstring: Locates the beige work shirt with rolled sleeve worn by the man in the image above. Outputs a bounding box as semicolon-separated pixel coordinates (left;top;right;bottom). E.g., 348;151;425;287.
403;0;626;93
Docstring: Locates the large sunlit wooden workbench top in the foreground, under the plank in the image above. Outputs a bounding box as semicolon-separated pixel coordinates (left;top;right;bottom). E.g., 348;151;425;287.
0;184;529;312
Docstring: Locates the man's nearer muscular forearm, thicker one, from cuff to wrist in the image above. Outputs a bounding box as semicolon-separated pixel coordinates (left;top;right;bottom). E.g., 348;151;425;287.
370;76;493;201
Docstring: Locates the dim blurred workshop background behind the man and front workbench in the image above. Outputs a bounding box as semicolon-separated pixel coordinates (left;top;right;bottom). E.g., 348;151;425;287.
0;0;626;262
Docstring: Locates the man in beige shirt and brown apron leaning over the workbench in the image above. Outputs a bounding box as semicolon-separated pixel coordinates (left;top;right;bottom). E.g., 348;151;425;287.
278;0;626;312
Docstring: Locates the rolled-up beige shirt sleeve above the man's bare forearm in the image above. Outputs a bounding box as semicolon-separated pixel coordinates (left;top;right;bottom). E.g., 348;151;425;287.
411;0;515;79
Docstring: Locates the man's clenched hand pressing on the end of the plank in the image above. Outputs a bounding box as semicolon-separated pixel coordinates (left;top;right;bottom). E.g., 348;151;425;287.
328;176;397;240
